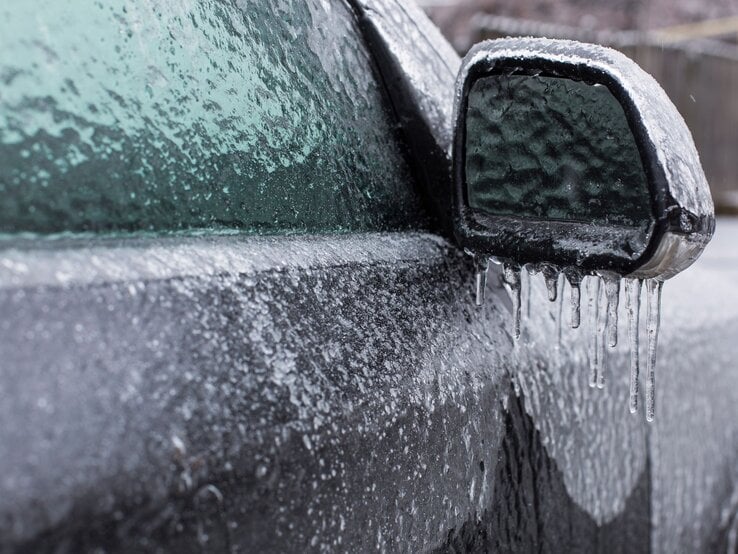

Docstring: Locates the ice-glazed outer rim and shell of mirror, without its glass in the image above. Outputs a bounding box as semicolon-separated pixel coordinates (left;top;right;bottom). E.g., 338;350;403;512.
454;38;714;279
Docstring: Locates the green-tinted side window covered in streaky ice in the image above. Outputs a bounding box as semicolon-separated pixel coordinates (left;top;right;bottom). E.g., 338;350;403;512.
0;0;419;236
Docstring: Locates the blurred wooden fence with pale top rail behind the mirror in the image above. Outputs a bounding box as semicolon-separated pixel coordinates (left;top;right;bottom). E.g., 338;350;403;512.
470;14;738;213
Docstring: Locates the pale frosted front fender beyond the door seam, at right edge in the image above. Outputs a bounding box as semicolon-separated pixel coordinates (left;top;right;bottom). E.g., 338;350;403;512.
641;219;738;552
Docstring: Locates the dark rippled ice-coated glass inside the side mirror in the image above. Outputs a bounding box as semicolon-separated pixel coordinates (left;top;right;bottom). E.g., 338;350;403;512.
464;75;653;231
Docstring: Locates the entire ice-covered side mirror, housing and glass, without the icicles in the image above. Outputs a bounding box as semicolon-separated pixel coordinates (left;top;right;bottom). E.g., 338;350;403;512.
453;38;715;280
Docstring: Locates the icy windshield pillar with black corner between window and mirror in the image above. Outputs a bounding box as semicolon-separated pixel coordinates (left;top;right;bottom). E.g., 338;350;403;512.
347;0;461;237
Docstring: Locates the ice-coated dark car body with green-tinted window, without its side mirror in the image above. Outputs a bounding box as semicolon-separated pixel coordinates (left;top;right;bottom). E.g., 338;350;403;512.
0;0;738;553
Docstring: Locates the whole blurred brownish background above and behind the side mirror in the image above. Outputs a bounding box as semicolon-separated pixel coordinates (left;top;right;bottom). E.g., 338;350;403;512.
418;0;738;214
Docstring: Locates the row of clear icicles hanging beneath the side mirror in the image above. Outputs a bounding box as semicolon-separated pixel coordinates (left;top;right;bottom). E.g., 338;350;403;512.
476;258;664;421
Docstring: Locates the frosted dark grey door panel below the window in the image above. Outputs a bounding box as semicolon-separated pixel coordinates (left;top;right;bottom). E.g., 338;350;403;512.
0;234;645;552
